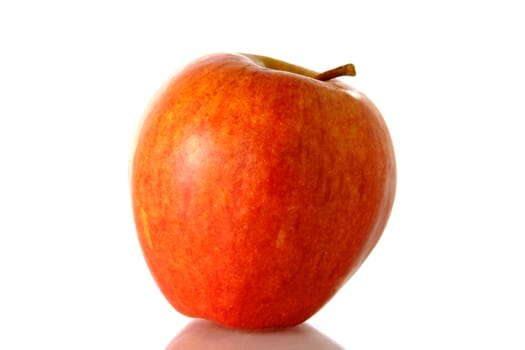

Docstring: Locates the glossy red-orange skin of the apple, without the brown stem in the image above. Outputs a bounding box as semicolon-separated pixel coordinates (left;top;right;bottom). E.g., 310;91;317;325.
131;54;396;329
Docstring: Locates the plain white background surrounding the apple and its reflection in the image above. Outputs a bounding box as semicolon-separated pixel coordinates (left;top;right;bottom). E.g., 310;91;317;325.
0;0;525;349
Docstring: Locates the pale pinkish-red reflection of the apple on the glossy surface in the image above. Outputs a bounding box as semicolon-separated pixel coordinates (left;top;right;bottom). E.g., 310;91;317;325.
166;320;344;350
